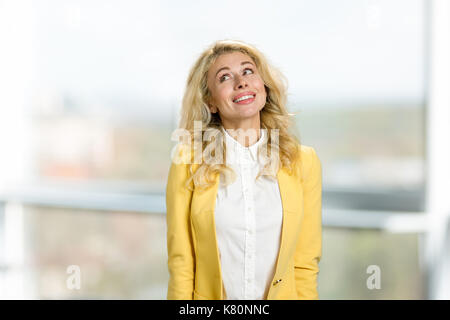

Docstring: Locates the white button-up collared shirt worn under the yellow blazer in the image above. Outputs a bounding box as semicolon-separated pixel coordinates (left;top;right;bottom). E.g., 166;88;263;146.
215;127;283;300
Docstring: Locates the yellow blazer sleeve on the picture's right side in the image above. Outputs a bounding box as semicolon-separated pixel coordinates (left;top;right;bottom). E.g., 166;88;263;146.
294;147;322;300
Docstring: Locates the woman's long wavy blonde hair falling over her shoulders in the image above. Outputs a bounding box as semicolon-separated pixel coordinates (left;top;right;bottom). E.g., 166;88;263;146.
174;40;300;189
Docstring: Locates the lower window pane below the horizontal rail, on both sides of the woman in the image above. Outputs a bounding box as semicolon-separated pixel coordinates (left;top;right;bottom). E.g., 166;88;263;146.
3;207;427;300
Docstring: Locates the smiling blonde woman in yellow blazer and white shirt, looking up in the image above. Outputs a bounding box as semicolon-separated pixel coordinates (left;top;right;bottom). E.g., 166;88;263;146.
166;40;322;300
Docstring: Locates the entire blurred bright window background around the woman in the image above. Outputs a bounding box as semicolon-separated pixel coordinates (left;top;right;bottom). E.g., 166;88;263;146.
0;0;450;299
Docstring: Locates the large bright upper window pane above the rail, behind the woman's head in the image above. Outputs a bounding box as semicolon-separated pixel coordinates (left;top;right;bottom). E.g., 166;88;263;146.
0;0;426;196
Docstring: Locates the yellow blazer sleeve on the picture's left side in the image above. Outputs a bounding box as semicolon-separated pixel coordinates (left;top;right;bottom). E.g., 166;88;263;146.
166;146;195;300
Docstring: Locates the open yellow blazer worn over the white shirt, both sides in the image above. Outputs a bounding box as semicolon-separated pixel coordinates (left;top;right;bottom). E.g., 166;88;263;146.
166;145;322;300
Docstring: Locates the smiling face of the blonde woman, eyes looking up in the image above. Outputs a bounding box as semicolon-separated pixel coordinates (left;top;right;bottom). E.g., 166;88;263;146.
207;52;266;127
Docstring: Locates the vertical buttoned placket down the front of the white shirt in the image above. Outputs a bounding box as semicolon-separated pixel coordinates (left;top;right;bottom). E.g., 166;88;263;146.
239;150;256;300
